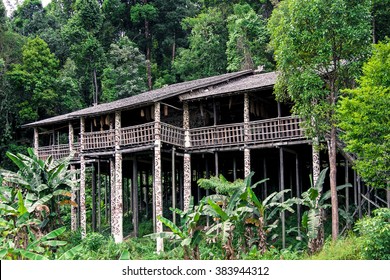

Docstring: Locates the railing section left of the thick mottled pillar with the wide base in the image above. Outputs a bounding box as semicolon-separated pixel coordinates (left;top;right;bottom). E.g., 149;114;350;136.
84;129;115;151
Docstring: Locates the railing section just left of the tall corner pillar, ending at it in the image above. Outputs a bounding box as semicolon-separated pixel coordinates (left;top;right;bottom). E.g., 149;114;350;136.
120;122;154;146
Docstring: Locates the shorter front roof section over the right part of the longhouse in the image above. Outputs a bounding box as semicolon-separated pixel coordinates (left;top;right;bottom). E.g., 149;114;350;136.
180;72;277;100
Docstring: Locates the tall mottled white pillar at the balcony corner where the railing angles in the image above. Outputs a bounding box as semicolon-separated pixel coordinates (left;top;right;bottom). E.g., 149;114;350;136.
154;102;164;252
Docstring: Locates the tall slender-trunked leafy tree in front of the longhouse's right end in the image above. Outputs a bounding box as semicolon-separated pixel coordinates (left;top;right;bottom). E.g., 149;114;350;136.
269;0;371;240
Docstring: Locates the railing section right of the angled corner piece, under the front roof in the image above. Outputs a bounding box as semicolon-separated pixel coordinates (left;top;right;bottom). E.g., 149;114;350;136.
190;123;244;148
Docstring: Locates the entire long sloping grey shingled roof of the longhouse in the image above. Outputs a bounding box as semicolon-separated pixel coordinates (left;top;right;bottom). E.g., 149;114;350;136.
23;70;276;127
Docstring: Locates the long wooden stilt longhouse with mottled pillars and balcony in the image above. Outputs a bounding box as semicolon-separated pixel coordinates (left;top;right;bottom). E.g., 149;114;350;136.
25;70;376;250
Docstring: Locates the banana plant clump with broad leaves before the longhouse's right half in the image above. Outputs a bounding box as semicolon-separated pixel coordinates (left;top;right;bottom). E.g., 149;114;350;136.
202;172;296;259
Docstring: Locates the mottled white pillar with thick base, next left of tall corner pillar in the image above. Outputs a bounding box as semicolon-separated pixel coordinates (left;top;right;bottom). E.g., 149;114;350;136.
111;111;123;243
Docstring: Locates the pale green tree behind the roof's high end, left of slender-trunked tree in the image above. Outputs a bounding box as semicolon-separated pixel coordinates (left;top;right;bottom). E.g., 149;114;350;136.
226;4;271;71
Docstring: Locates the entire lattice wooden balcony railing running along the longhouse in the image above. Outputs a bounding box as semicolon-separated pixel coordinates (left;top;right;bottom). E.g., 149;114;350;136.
35;116;305;159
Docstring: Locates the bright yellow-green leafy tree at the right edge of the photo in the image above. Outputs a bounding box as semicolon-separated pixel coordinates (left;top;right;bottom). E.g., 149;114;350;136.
337;41;390;188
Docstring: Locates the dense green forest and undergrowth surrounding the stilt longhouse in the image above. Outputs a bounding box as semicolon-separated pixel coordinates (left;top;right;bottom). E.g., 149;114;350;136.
0;0;390;259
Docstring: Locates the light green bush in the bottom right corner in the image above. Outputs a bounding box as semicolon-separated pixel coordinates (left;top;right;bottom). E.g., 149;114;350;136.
355;208;390;260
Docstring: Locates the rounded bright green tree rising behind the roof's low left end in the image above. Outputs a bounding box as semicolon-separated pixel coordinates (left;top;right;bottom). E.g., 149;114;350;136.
7;37;58;122
